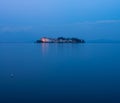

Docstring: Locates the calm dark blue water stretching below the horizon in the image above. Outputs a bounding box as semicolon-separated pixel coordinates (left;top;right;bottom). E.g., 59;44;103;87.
0;43;120;103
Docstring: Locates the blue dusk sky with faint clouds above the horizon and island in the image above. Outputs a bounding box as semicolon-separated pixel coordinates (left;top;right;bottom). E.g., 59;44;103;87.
0;0;120;42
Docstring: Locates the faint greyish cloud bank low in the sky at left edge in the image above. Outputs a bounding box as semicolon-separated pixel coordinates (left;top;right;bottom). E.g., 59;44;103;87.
0;25;32;32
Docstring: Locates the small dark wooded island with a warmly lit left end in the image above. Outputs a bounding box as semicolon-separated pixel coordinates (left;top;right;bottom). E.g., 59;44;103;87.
36;37;85;43
